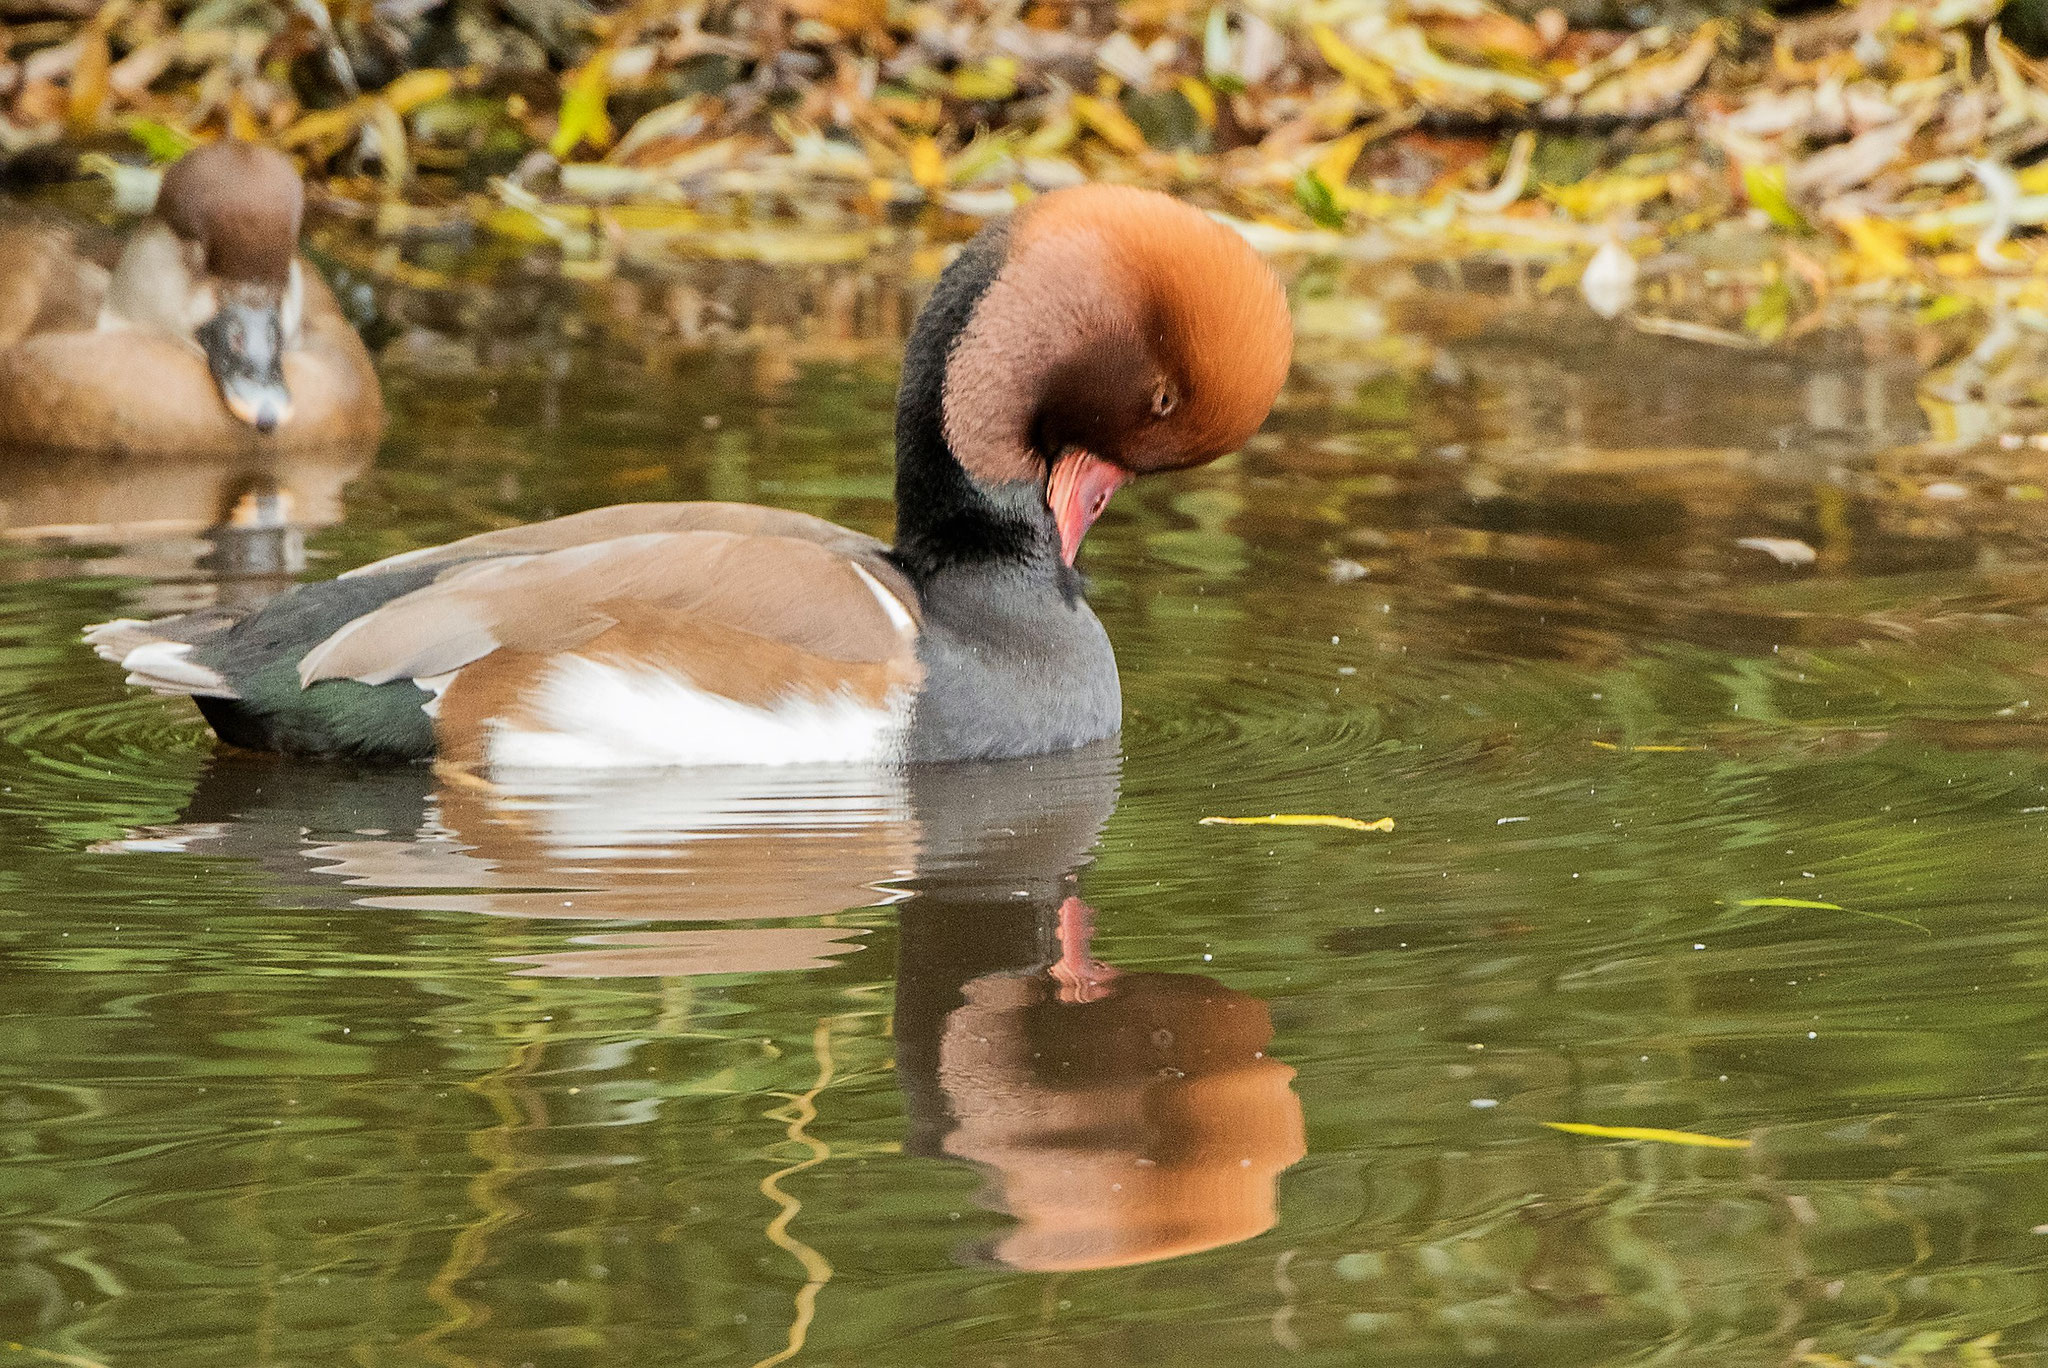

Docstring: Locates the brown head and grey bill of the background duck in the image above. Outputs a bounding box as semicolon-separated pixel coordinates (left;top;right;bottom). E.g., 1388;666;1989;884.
156;139;305;432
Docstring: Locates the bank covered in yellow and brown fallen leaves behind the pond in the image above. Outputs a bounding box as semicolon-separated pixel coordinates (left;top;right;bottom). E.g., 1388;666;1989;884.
0;0;2048;307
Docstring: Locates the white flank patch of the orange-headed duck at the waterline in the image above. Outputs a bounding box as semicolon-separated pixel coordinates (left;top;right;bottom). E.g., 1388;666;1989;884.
489;655;909;770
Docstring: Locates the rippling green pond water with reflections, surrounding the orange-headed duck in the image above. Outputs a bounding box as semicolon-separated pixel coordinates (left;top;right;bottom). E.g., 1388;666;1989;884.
0;259;2048;1368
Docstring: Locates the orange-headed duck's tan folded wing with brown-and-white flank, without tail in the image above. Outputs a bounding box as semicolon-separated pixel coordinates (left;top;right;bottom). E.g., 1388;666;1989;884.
321;528;920;766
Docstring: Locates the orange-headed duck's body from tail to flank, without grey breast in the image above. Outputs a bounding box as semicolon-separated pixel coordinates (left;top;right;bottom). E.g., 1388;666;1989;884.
88;510;922;766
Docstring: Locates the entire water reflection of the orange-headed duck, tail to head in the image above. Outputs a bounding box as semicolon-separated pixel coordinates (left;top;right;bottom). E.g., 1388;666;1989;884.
108;747;1305;1270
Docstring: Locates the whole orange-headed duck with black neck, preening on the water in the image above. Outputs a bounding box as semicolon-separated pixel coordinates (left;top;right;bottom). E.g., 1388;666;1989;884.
88;186;1290;770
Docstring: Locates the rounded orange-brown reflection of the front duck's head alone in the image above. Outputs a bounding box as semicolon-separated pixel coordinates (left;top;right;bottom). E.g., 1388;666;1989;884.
938;973;1305;1270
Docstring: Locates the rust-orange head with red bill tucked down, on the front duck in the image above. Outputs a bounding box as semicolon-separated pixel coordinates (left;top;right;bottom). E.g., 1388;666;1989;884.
944;186;1292;563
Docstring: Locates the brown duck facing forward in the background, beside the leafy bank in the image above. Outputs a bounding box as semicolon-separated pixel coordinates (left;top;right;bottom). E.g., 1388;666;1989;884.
0;141;385;457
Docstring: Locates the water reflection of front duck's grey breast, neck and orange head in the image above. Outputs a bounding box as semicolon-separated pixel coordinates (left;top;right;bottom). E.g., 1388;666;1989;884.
895;758;1305;1270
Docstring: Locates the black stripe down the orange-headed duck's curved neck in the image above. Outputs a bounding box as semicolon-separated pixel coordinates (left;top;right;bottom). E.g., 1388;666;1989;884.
895;223;1071;586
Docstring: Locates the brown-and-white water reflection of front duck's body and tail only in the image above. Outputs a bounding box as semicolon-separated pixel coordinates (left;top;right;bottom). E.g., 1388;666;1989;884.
117;750;915;979
